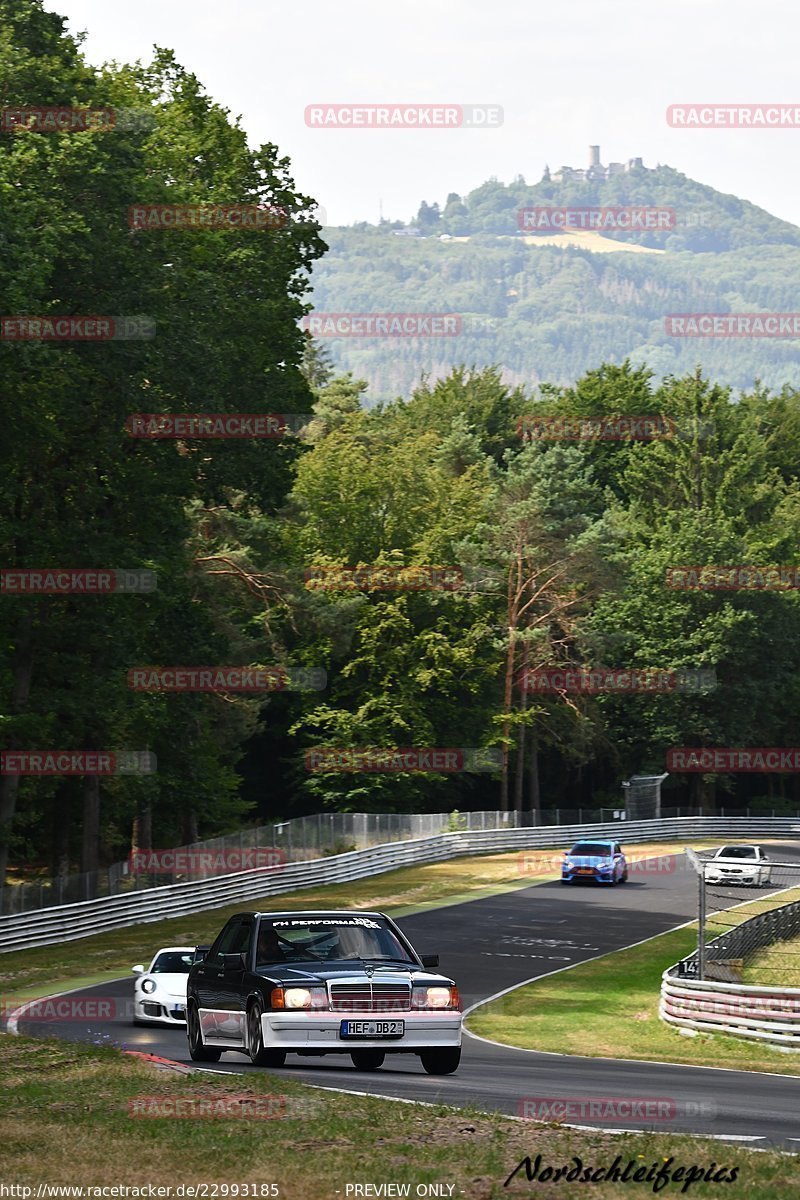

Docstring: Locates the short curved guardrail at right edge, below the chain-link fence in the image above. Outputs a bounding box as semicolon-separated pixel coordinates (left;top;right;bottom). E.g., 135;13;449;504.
658;900;800;1050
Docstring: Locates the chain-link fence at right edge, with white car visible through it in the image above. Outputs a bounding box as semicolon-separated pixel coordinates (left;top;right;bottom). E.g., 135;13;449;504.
676;844;800;988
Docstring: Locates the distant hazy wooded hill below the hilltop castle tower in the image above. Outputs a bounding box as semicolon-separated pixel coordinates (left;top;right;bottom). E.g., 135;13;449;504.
314;167;800;401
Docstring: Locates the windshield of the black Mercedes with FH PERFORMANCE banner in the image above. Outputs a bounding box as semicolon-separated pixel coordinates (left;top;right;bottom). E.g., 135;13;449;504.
255;914;417;966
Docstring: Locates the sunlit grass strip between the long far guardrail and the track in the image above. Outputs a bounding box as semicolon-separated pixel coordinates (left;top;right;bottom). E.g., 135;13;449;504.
0;842;706;1002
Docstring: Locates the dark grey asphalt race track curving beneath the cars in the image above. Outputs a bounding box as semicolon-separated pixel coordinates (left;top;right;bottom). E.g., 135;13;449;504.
9;842;800;1152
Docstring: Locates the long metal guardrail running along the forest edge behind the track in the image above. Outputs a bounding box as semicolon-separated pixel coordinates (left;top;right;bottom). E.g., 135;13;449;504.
0;817;800;953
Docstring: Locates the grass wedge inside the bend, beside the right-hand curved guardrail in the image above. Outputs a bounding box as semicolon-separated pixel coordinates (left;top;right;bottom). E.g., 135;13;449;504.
467;928;800;1075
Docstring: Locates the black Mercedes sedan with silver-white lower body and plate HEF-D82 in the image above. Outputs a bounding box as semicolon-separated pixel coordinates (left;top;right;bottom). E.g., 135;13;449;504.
186;911;462;1075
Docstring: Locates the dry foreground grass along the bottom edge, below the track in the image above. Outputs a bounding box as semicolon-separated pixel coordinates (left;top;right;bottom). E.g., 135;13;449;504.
0;1034;798;1200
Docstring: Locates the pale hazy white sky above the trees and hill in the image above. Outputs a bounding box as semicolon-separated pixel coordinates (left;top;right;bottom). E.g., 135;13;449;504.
46;0;800;224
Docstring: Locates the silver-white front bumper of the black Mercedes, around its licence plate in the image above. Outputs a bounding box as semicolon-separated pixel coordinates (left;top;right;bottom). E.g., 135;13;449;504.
261;1010;462;1054
